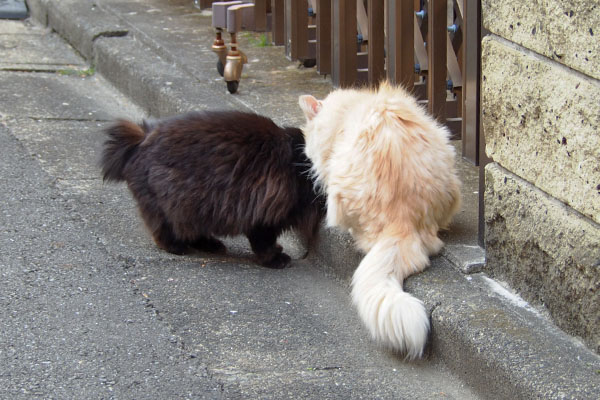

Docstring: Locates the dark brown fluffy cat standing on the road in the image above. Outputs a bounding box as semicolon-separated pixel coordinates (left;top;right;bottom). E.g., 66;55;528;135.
101;111;324;268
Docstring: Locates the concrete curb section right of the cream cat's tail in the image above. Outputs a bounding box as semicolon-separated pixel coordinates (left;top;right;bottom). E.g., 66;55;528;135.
405;257;600;400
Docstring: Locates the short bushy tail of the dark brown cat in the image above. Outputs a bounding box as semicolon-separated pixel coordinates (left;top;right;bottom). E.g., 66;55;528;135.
100;120;145;181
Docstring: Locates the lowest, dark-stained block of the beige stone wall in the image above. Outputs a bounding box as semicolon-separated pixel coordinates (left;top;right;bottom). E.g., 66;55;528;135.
485;163;600;351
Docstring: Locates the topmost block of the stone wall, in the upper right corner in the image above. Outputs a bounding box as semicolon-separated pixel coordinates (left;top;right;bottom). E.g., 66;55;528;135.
481;0;600;79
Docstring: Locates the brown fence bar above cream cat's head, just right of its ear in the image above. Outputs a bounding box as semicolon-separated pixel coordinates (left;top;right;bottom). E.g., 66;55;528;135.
331;0;357;87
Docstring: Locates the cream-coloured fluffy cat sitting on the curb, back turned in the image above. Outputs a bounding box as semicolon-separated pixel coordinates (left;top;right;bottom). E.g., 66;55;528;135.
299;83;460;359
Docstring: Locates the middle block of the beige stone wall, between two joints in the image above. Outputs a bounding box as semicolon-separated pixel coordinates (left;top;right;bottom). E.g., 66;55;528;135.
482;36;600;223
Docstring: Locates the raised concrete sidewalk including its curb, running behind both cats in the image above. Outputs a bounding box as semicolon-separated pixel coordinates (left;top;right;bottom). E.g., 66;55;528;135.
16;0;600;398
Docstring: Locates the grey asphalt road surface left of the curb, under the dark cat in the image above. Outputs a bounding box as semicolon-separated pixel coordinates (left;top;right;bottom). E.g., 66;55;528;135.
0;20;476;399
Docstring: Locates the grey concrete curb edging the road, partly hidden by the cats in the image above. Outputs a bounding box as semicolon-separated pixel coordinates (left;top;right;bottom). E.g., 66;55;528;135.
28;0;600;399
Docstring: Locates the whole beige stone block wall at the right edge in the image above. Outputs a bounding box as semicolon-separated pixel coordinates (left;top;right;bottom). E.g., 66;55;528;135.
481;0;600;352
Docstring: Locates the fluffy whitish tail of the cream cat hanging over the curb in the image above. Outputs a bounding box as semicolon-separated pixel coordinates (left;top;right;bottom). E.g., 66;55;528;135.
352;237;429;359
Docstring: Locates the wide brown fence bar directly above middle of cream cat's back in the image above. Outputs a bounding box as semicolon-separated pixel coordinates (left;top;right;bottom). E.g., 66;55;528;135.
387;0;415;91
